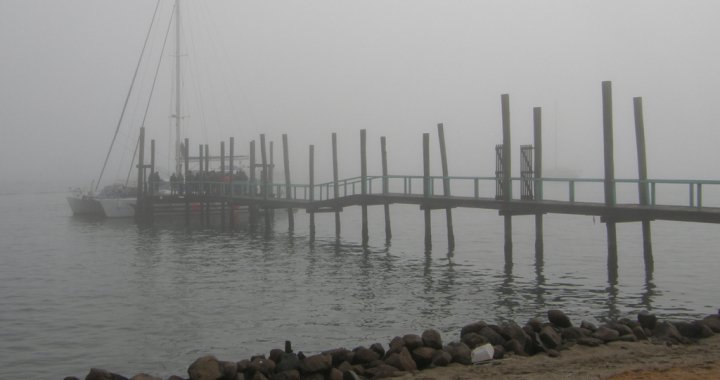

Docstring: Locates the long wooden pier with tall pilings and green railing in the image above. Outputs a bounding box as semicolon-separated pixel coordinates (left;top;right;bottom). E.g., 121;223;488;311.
136;82;720;274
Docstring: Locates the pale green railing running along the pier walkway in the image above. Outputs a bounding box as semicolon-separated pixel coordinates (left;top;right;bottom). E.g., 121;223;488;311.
176;175;720;208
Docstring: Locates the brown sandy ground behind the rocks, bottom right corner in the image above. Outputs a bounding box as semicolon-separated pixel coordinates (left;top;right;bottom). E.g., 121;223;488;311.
396;335;720;380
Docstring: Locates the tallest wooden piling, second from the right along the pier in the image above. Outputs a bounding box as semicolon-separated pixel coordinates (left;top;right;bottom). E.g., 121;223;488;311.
602;81;617;270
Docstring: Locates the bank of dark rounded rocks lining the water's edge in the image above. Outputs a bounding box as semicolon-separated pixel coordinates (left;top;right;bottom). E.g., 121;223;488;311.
64;310;720;380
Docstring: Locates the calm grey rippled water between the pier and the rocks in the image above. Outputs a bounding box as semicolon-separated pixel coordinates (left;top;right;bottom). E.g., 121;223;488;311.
0;193;720;379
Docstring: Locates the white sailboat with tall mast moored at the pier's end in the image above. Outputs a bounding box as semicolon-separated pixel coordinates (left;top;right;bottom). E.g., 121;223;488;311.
67;0;195;218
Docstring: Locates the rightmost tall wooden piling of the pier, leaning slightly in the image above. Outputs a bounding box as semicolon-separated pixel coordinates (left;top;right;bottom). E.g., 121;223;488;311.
633;97;655;273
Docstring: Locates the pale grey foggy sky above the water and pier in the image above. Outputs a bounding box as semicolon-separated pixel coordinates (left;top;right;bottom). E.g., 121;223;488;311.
0;0;720;189
